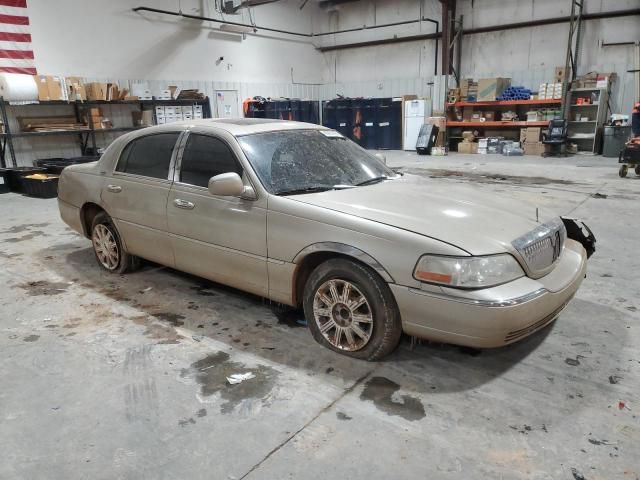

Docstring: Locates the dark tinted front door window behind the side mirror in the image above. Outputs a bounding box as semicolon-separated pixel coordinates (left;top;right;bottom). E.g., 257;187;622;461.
180;134;242;187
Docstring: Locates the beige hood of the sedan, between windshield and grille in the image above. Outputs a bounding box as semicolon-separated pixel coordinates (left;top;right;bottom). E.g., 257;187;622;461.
289;174;550;255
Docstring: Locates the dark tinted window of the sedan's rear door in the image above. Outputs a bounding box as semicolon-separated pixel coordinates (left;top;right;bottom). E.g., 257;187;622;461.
116;133;180;180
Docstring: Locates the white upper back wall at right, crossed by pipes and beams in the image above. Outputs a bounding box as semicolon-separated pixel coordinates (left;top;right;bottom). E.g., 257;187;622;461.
316;0;640;111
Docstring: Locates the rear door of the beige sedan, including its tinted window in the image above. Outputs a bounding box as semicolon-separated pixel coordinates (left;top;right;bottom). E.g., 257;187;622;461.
102;132;182;266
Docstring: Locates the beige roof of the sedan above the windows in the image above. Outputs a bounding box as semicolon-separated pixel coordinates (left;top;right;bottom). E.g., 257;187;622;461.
151;118;327;136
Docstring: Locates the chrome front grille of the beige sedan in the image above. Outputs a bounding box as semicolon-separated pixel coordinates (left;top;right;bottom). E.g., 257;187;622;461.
511;218;567;276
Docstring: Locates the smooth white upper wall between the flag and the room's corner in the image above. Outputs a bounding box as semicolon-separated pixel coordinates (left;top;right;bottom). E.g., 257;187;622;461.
29;0;324;83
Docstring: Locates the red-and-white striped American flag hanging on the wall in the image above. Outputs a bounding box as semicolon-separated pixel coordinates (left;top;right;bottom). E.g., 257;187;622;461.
0;0;38;75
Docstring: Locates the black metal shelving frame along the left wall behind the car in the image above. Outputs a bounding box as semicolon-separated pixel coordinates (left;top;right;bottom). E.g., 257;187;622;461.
0;97;211;168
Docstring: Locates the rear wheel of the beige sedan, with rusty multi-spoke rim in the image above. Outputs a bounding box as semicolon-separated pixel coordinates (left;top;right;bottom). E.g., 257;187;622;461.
91;212;140;273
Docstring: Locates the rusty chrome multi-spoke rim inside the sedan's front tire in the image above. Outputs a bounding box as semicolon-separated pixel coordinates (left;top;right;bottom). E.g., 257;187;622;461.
313;279;373;352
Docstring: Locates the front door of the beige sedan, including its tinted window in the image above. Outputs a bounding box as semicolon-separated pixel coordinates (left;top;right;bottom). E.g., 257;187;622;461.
167;133;268;296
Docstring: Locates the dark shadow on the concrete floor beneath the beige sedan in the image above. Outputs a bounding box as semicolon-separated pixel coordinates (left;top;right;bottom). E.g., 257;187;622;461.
39;241;551;391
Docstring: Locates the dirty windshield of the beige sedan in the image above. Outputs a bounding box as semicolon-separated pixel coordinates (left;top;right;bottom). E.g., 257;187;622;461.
238;130;396;195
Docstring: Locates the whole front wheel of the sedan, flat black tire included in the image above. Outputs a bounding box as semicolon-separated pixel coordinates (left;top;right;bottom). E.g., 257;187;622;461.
303;258;402;360
